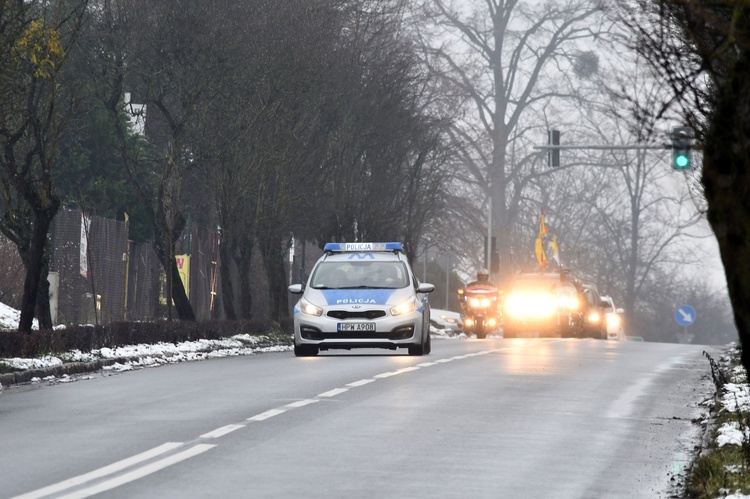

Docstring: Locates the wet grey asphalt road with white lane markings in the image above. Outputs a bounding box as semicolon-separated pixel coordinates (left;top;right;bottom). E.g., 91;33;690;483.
0;338;719;498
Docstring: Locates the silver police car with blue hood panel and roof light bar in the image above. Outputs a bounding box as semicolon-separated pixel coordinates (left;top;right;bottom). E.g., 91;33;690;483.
289;243;435;357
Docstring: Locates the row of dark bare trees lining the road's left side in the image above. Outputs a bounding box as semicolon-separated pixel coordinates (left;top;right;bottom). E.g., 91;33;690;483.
0;0;446;330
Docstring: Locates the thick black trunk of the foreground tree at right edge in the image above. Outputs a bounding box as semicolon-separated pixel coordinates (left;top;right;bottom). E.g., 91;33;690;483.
702;52;750;372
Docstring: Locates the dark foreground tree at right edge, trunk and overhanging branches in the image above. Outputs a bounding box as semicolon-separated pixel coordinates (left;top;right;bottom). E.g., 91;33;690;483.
621;0;750;369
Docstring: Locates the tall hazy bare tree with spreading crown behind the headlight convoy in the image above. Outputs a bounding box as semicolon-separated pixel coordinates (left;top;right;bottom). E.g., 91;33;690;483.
414;0;608;286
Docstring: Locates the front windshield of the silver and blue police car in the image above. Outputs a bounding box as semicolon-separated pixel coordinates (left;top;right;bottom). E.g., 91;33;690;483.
310;261;409;289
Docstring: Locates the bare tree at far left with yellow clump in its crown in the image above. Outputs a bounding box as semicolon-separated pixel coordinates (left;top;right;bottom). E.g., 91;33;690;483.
0;0;86;331
